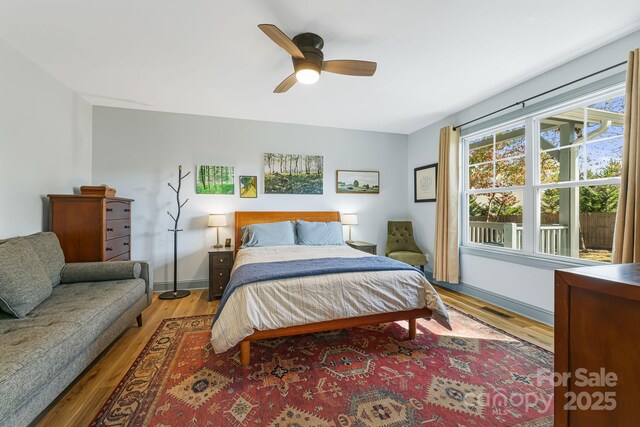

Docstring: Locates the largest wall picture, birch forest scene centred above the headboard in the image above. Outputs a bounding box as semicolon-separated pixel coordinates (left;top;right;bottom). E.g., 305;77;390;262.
264;153;324;194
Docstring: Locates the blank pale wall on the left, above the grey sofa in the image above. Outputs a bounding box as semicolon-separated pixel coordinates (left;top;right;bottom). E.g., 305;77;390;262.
0;40;91;238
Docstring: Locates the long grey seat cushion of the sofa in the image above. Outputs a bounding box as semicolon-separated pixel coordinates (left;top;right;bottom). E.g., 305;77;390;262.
0;279;146;420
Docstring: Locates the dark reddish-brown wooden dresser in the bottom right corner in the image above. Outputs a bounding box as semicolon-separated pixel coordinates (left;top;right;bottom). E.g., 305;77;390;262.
554;264;640;426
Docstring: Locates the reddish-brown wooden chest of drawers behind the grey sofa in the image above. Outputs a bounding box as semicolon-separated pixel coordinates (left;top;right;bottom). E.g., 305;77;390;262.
48;194;133;262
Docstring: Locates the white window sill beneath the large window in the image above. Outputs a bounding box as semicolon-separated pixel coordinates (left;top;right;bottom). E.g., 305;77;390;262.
460;245;606;270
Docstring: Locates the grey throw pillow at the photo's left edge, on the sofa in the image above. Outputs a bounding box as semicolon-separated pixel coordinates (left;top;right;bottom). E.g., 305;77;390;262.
0;239;52;318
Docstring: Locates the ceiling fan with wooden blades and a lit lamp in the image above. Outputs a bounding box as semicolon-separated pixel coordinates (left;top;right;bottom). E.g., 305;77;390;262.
258;24;377;93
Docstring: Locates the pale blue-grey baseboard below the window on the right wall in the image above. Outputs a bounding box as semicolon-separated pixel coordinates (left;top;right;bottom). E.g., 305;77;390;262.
427;271;553;326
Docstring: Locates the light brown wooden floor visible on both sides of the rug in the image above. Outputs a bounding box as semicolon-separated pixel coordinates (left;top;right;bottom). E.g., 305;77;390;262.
35;288;553;427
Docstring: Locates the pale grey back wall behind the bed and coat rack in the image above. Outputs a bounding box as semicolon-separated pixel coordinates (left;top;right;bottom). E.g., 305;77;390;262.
93;107;407;282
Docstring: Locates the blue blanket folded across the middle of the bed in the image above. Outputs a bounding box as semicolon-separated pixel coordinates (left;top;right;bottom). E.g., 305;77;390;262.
213;256;422;323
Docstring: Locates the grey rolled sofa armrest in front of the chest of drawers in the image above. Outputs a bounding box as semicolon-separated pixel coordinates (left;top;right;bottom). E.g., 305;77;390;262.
62;261;142;283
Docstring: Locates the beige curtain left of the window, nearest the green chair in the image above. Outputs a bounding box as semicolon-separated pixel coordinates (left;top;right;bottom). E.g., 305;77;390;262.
433;126;460;283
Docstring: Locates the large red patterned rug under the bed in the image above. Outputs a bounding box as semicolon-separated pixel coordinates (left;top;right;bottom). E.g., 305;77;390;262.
92;309;553;427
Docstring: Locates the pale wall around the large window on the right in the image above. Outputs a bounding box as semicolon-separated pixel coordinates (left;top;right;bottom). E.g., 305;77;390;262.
407;32;640;312
